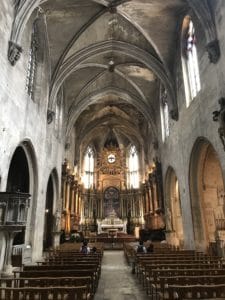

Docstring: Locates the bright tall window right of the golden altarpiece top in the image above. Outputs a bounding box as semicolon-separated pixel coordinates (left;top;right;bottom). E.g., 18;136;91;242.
127;146;139;188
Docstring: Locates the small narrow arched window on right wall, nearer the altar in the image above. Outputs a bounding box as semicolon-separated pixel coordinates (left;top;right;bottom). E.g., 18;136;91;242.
160;91;170;142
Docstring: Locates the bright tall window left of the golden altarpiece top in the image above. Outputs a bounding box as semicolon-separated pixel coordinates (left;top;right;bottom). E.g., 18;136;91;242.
83;147;94;189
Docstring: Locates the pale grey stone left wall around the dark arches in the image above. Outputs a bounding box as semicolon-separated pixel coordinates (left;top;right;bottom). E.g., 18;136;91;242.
0;1;64;267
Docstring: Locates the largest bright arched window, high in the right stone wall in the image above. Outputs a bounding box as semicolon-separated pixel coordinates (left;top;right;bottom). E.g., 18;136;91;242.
182;17;201;107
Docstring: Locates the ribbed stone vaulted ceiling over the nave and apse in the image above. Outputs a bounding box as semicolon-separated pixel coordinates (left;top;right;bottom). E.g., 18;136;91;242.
38;0;187;158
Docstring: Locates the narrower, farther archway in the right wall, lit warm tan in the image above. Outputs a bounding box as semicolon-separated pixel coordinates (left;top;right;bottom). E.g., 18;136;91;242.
165;167;184;247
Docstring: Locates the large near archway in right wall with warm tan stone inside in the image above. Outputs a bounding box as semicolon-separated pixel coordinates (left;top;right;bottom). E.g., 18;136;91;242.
189;138;224;250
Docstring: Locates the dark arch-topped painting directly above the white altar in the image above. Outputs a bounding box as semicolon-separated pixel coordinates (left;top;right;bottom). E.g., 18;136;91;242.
104;187;120;218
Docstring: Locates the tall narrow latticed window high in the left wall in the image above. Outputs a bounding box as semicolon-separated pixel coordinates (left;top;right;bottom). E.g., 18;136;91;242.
26;23;37;100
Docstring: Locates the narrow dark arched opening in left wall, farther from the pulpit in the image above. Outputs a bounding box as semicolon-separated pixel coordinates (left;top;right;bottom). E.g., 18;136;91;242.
43;176;54;250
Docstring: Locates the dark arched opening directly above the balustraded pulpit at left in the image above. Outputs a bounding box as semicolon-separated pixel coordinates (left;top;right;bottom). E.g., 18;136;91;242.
7;147;30;193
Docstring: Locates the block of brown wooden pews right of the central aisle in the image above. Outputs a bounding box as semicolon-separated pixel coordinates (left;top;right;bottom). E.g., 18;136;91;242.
124;245;225;300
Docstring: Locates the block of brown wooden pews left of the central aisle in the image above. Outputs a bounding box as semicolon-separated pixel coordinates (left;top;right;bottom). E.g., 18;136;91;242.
0;243;103;300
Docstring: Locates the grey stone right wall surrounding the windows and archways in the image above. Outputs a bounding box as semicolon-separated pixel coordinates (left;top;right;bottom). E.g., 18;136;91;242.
158;1;225;248
